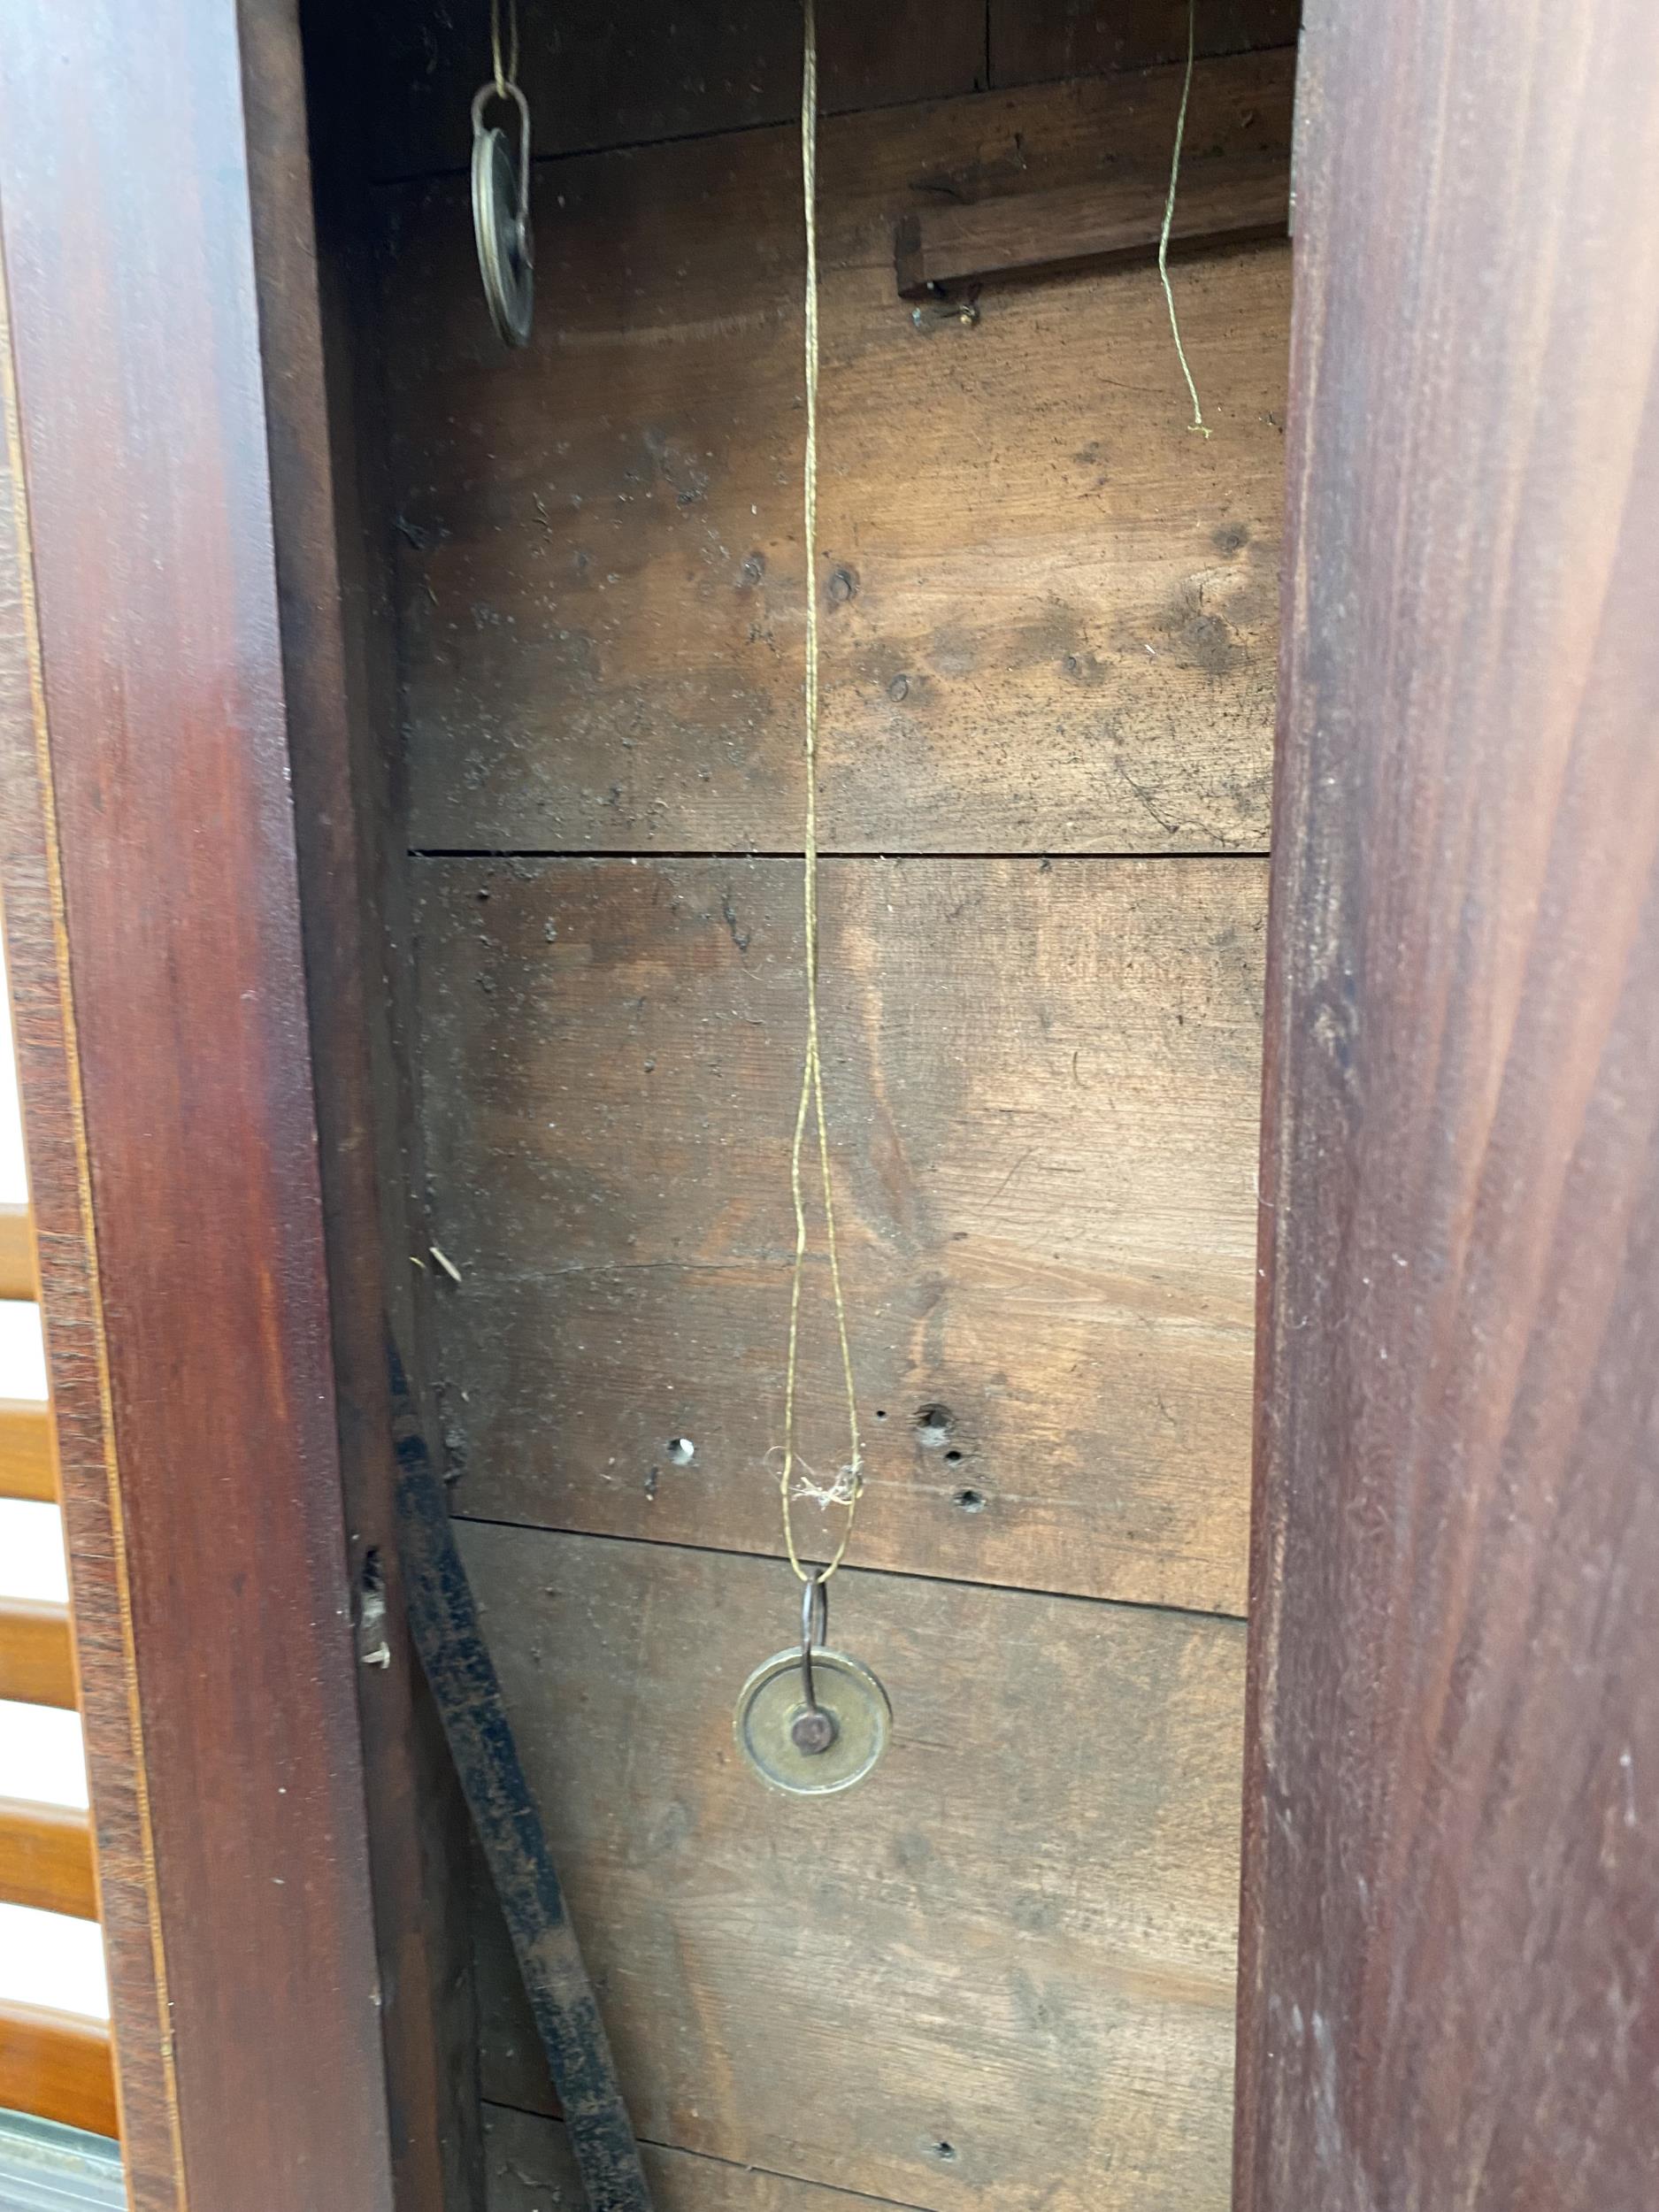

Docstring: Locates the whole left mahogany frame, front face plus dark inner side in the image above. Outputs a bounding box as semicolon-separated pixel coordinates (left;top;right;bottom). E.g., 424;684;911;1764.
0;0;462;2212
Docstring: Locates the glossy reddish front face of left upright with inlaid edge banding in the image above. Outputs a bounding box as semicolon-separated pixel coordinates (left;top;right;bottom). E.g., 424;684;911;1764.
0;0;403;2212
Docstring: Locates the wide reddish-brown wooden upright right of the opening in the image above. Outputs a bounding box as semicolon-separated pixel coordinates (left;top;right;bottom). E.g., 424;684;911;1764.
1237;0;1659;2212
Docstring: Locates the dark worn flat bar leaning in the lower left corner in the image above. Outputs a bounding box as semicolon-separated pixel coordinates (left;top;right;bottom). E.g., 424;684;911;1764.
388;1343;650;2212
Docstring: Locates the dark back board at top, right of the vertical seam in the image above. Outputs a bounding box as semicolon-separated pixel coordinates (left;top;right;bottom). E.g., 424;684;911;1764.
987;0;1301;84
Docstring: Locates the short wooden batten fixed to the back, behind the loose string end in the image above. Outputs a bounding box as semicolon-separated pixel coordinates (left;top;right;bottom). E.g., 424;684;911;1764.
894;153;1290;299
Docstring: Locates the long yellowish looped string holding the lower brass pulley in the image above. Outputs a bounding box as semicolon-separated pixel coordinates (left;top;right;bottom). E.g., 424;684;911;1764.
779;0;863;1582
